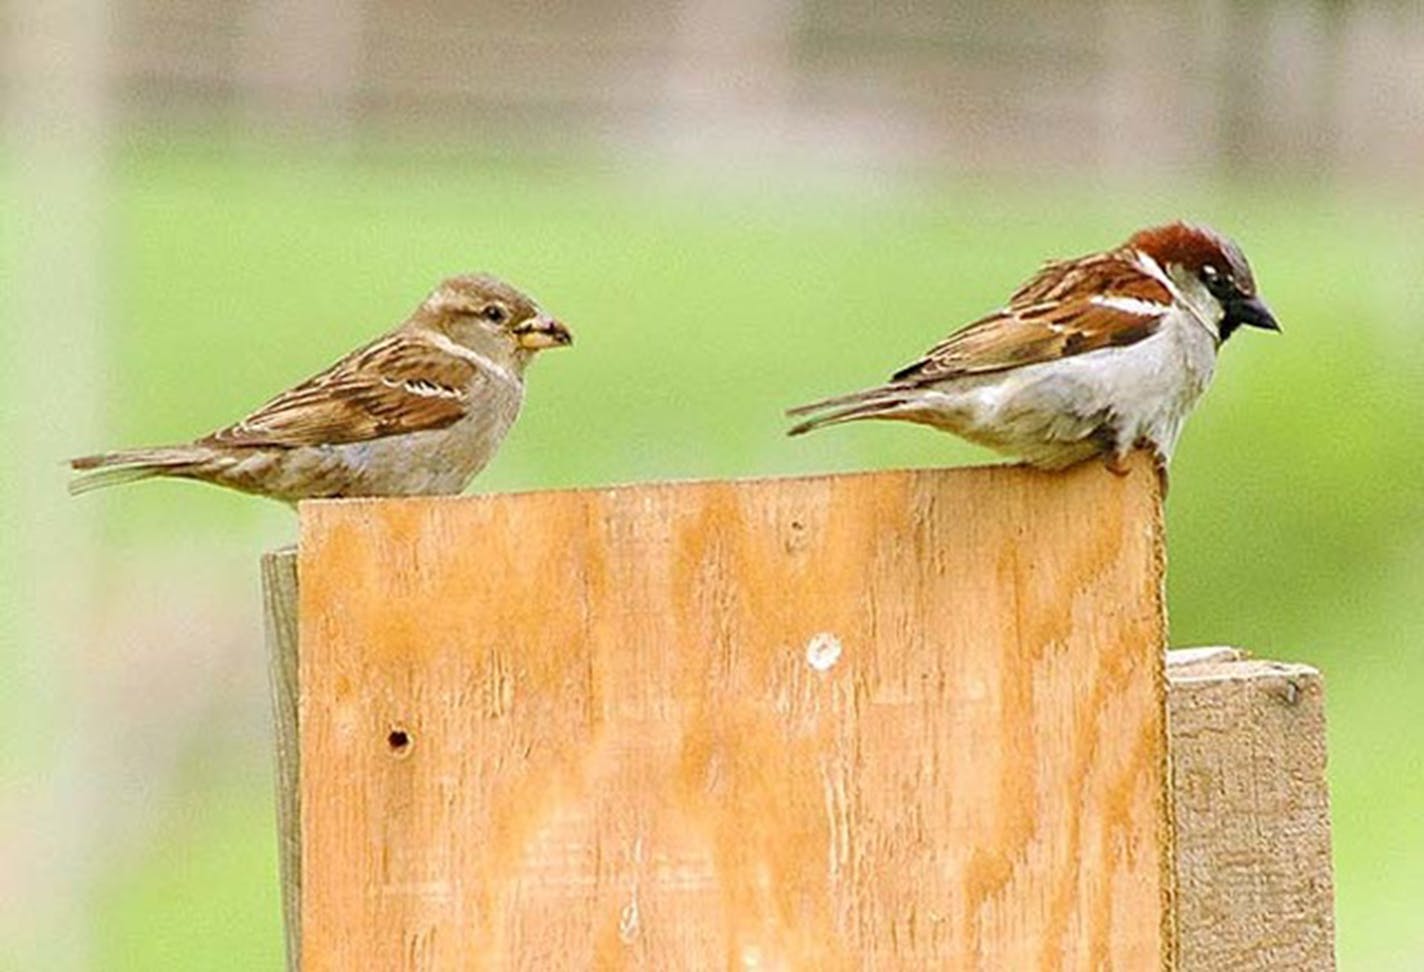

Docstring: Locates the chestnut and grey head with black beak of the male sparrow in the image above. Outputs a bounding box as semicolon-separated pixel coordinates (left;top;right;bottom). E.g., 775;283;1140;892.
1128;222;1280;340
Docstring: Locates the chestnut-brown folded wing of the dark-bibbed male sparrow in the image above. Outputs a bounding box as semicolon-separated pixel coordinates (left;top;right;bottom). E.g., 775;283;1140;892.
893;253;1172;384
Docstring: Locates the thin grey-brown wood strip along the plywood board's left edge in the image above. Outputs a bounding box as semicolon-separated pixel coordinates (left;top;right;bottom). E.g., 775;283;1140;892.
262;546;302;972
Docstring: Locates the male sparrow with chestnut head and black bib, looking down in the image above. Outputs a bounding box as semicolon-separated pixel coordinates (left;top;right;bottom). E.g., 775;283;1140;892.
787;222;1280;472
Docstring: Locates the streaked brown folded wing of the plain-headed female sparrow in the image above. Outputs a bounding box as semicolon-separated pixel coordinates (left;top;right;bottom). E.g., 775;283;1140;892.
202;332;483;447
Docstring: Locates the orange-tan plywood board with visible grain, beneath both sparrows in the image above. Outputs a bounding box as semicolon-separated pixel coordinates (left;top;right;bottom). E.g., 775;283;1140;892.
289;465;1172;969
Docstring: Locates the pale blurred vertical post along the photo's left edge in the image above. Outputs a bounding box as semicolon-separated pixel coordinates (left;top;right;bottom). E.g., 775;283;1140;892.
0;0;111;969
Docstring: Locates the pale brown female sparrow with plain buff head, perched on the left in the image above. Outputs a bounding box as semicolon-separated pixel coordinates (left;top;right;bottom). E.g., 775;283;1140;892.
70;275;572;502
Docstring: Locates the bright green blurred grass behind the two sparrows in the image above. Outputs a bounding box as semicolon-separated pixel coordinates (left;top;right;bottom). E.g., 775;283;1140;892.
0;142;1424;969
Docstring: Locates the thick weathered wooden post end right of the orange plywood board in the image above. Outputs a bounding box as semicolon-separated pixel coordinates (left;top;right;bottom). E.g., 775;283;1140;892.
1168;652;1334;972
